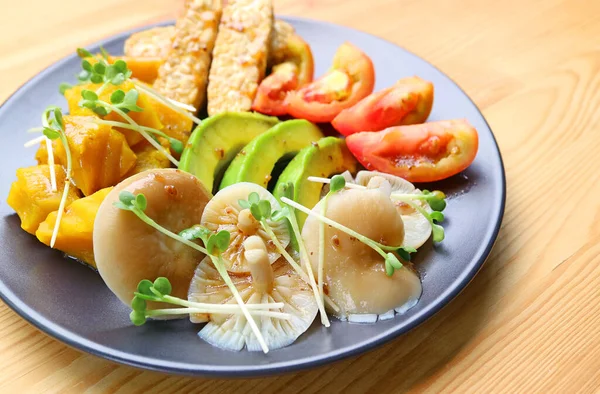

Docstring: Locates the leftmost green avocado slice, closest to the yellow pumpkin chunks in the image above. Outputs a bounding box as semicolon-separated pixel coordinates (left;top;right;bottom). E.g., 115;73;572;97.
179;112;279;191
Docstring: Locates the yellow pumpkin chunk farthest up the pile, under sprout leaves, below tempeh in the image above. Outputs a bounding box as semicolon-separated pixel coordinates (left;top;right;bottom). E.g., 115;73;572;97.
65;81;163;146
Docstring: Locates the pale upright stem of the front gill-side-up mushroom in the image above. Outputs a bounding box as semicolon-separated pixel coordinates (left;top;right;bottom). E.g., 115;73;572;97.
244;235;273;294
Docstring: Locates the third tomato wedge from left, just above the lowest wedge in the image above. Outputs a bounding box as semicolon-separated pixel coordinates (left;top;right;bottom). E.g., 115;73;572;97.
331;77;433;136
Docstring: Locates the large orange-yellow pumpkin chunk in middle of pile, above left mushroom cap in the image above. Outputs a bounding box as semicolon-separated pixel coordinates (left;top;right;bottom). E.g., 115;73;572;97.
36;115;136;196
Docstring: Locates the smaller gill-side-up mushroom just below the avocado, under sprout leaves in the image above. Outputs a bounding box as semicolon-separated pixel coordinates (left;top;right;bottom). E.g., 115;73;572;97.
201;182;290;274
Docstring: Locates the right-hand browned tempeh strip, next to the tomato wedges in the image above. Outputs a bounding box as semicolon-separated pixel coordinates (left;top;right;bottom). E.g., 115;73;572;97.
207;0;273;115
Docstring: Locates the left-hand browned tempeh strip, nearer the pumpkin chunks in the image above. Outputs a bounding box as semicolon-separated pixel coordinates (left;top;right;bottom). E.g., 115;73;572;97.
154;0;221;108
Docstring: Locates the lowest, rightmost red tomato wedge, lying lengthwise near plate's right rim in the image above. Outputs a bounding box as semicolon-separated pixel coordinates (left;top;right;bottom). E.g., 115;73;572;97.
346;119;479;182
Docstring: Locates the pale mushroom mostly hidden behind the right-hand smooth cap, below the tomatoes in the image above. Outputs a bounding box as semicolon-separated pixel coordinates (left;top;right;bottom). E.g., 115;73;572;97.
354;171;432;249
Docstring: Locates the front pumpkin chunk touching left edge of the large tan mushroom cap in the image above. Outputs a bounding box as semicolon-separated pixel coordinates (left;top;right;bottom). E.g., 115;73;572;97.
35;187;112;268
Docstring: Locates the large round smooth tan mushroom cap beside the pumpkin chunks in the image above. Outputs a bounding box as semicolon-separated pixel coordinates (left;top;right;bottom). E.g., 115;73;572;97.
93;169;211;309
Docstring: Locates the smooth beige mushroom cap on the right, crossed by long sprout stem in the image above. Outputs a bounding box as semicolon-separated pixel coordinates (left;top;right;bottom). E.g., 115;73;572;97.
302;189;421;318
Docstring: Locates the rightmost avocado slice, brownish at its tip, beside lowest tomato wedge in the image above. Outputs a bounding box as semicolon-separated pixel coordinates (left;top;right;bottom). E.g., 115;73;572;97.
273;137;358;228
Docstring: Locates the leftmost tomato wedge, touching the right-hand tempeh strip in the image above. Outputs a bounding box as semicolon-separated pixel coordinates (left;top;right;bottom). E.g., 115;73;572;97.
252;35;314;116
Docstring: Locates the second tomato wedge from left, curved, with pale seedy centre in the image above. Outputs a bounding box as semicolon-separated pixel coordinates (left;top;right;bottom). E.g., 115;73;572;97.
285;43;375;123
